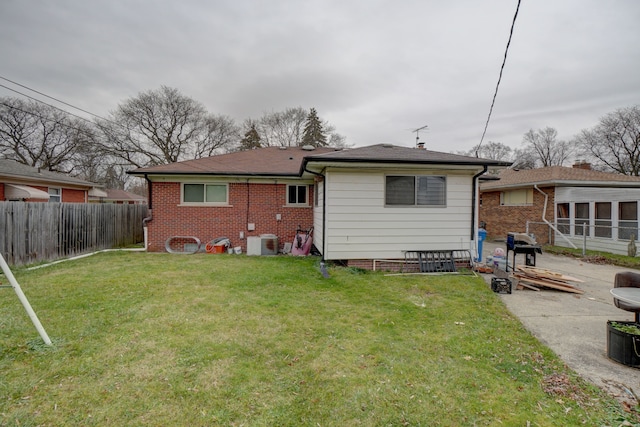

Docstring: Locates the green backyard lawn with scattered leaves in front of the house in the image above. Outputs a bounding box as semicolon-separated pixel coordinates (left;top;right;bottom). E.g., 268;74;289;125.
0;252;630;426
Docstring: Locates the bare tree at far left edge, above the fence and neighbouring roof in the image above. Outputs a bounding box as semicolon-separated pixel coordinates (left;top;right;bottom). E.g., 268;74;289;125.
0;98;94;172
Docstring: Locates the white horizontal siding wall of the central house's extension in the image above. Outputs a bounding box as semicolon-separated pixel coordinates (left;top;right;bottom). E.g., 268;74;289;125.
316;170;472;260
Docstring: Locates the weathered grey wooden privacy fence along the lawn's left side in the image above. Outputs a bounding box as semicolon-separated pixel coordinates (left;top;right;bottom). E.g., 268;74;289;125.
0;202;148;265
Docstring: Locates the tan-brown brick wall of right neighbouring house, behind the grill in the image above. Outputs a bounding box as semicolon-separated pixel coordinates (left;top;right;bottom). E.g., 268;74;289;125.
479;187;555;245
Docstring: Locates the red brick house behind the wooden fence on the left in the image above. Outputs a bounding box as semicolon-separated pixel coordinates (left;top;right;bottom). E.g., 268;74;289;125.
0;159;106;203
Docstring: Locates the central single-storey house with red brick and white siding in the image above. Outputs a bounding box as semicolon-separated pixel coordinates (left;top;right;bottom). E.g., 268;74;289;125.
129;144;509;268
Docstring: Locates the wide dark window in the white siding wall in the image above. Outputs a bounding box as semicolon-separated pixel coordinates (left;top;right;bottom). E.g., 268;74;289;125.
385;175;447;206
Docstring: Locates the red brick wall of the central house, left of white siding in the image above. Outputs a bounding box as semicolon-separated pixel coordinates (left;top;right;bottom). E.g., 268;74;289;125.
148;182;313;252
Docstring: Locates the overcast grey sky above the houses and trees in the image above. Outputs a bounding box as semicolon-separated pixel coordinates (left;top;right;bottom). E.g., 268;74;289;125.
0;0;640;152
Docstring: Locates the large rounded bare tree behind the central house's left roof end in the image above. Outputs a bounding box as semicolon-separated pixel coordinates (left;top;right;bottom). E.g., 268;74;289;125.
98;86;235;167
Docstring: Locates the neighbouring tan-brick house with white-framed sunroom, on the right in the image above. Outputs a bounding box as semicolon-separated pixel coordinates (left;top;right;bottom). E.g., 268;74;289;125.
480;163;640;254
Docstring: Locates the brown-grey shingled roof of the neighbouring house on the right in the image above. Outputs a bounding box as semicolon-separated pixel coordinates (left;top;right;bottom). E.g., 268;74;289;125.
480;166;640;191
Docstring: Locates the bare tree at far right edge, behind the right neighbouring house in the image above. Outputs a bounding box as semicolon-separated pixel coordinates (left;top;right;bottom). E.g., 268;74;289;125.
574;105;640;176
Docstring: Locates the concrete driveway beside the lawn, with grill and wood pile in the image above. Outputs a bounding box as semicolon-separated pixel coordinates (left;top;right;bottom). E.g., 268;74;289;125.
483;242;640;406
